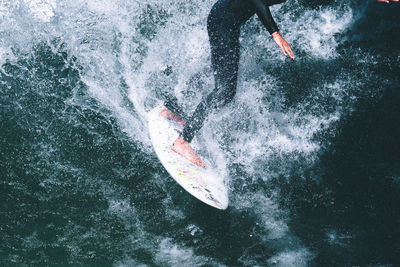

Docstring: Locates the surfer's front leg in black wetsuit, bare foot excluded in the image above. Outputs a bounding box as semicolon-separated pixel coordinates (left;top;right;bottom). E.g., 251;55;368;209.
182;0;240;142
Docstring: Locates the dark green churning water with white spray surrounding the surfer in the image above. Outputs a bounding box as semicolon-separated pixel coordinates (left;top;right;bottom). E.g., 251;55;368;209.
0;0;400;266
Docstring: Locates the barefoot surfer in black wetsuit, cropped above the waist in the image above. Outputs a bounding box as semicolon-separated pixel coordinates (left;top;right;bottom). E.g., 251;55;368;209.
161;0;294;167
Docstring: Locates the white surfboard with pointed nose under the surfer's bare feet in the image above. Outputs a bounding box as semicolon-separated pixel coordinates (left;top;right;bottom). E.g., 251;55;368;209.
148;106;228;209
